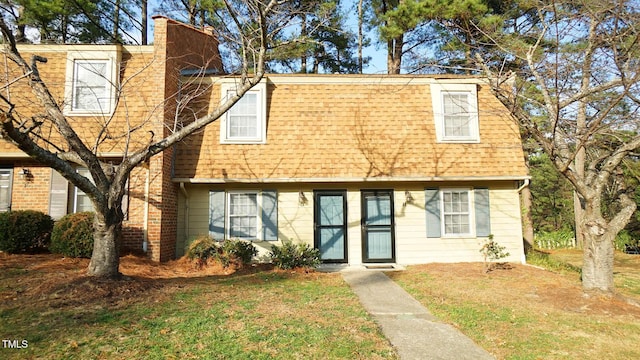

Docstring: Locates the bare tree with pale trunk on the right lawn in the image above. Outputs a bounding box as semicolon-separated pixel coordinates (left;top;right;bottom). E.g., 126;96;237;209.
478;0;640;292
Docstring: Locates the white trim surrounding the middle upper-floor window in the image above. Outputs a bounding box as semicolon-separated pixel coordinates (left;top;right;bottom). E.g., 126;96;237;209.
220;80;267;144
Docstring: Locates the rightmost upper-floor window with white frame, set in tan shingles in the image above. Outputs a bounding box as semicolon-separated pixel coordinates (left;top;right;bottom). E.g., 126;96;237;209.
431;84;480;143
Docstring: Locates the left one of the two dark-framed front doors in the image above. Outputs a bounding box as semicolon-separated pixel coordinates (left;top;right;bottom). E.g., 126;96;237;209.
314;191;347;263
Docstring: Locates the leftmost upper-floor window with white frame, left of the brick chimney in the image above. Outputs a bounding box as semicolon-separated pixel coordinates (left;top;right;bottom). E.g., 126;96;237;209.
65;48;118;116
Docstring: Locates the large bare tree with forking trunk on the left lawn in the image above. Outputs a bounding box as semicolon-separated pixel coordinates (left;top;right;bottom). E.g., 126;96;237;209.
0;0;286;278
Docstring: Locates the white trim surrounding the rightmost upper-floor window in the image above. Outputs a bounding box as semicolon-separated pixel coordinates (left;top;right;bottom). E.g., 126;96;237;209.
431;84;480;143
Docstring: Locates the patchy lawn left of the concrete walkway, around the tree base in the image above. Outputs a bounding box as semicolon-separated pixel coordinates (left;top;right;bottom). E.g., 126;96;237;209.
0;254;396;359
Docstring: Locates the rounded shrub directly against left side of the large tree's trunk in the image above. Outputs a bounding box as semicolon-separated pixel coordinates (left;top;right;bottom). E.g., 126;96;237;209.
49;212;94;258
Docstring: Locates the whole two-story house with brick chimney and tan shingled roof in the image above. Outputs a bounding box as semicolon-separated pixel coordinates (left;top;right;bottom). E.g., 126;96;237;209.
0;17;528;265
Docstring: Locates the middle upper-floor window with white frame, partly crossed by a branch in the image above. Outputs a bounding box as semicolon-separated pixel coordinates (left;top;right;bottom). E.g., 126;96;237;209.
220;83;267;144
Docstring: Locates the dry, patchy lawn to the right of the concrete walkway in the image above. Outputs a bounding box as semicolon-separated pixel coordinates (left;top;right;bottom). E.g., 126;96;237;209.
390;253;640;359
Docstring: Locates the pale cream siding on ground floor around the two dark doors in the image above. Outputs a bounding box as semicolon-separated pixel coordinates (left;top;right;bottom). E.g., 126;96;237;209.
178;182;524;265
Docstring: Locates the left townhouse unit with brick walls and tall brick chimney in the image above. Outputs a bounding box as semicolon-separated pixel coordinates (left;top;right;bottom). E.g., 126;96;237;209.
0;17;222;260
